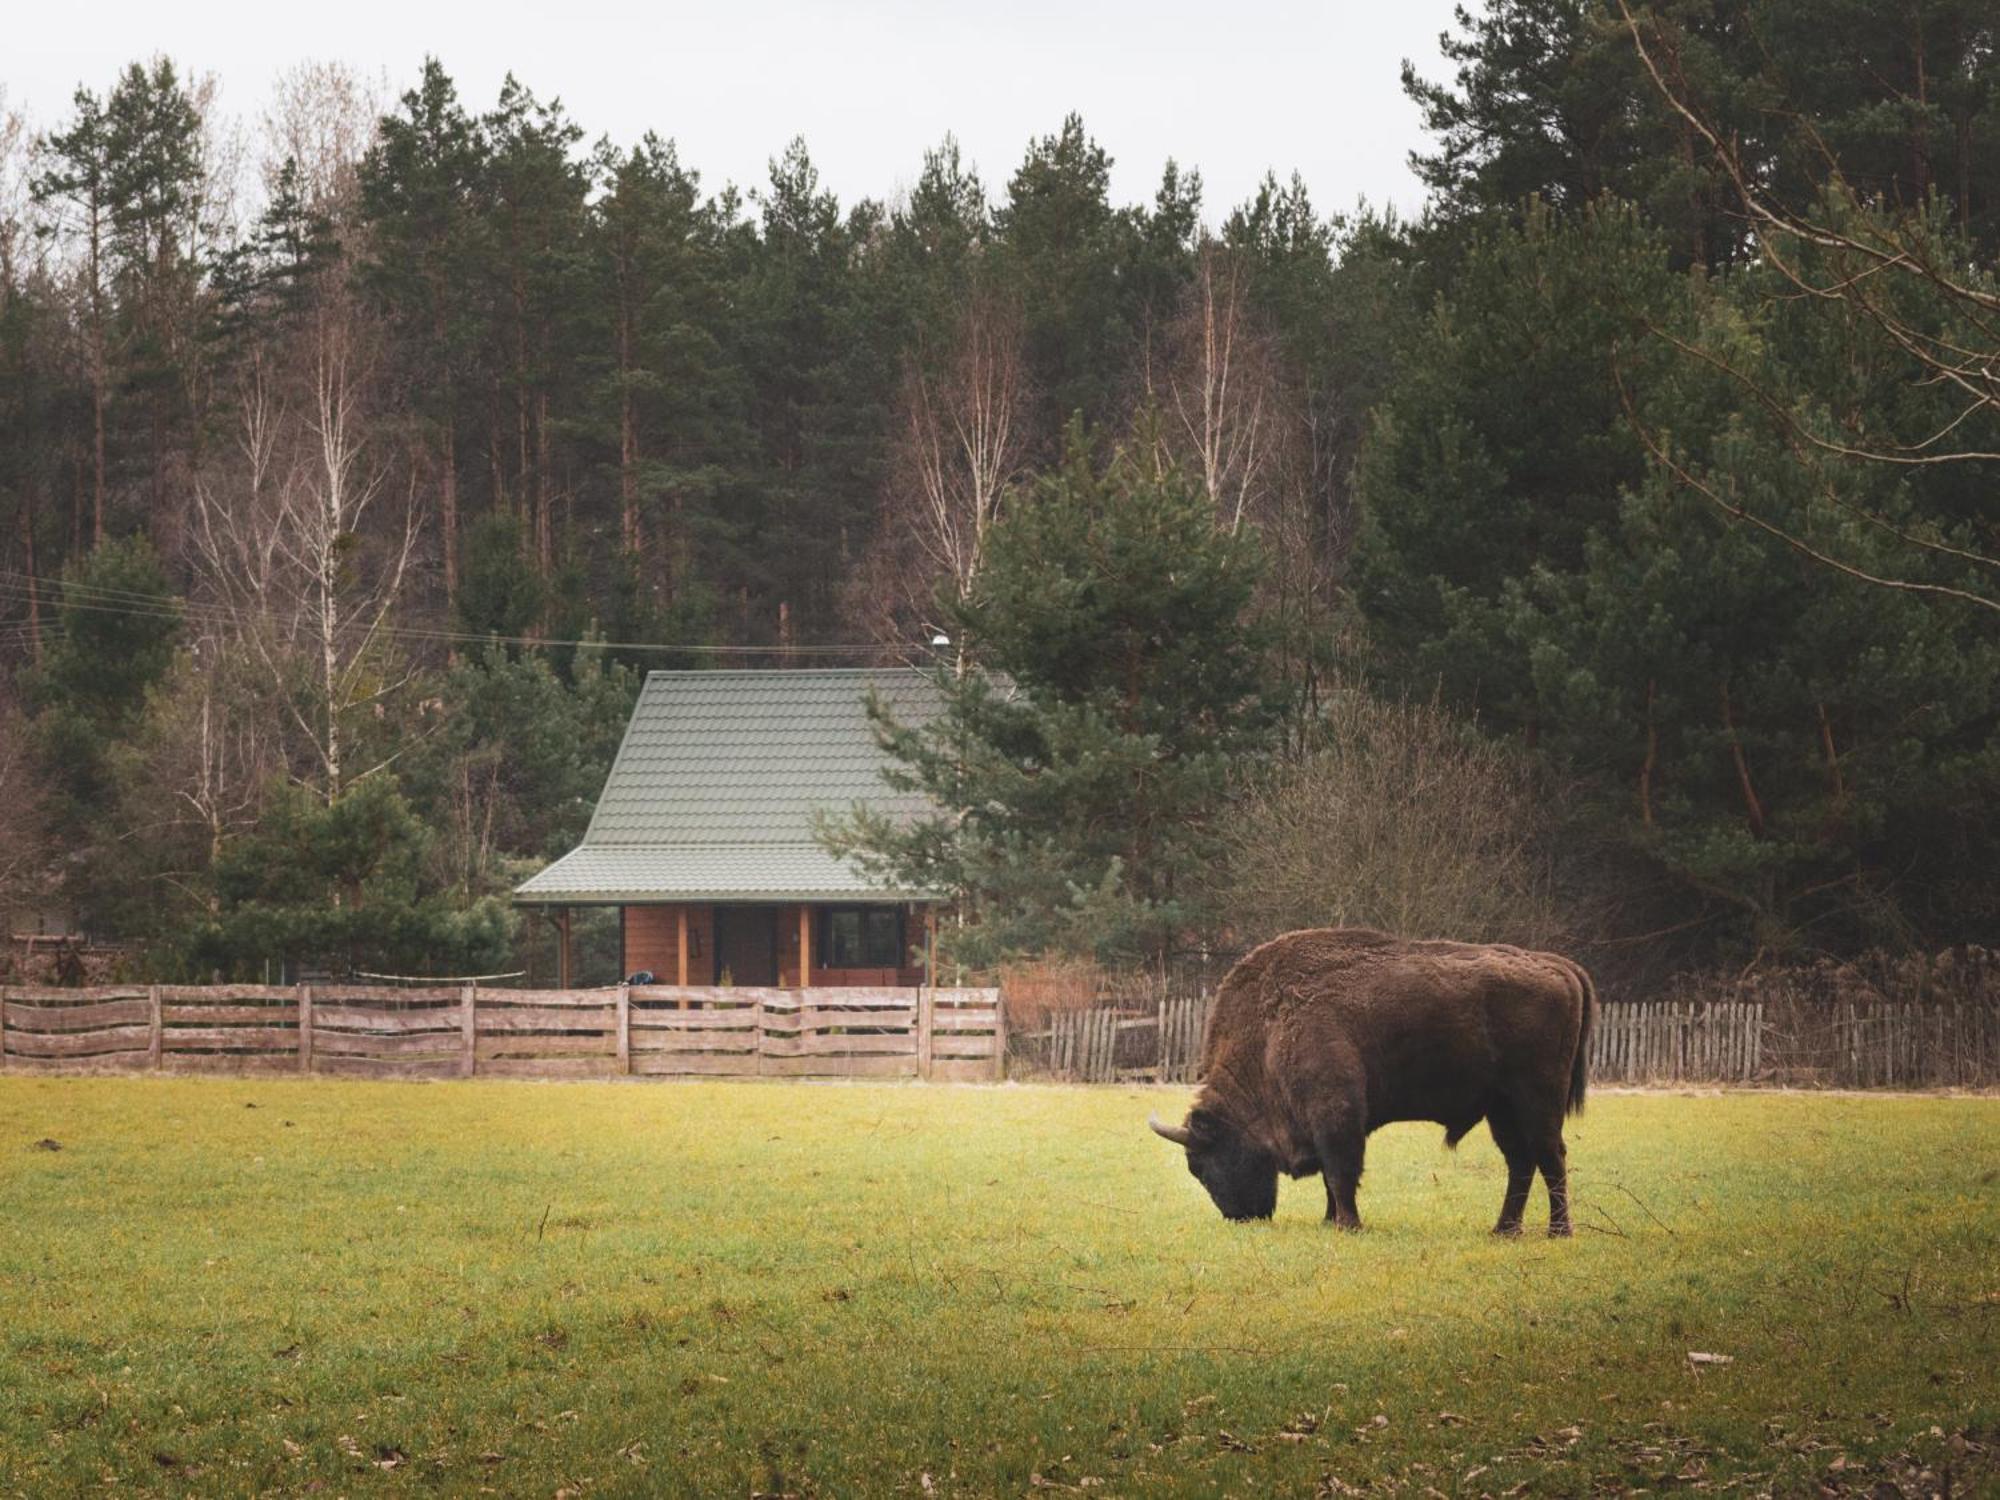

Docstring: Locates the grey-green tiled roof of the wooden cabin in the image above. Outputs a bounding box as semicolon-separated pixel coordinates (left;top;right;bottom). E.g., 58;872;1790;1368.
514;668;938;904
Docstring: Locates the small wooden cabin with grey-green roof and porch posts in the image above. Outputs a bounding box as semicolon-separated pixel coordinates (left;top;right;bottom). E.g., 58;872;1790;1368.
514;668;938;988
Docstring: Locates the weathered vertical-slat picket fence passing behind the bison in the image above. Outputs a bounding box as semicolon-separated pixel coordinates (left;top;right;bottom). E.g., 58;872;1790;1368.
1012;990;2000;1088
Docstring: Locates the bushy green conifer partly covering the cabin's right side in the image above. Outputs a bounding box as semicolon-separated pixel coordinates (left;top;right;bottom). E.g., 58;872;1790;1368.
822;424;1274;966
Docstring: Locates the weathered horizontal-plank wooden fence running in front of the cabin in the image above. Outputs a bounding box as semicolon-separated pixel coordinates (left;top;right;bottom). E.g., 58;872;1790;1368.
0;984;1006;1080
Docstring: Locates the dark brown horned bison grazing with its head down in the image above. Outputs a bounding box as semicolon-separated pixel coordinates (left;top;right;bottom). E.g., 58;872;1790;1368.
1150;928;1598;1234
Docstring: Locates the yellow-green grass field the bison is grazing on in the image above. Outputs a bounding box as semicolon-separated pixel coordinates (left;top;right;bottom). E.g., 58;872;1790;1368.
0;1078;2000;1496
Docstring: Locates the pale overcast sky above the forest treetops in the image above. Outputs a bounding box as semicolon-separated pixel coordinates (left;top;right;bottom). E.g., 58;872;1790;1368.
0;0;1452;222
